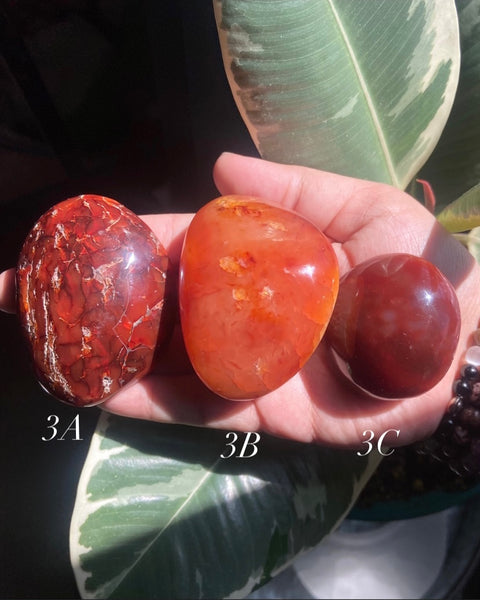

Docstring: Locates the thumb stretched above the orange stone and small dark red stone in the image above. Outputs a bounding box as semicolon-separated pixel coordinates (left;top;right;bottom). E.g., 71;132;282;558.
214;153;472;285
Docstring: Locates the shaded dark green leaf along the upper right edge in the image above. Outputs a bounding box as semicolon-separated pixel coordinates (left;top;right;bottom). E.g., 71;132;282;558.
421;0;480;207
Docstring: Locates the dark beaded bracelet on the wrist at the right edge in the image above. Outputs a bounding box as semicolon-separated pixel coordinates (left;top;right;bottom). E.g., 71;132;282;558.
416;329;480;478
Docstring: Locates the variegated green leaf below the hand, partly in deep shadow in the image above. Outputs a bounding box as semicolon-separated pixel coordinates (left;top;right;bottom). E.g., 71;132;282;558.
70;413;378;599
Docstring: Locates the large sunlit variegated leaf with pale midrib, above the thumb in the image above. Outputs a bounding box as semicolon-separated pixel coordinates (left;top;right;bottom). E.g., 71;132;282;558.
214;0;460;188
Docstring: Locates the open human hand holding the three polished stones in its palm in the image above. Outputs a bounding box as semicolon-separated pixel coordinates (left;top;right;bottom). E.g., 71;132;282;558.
0;154;480;447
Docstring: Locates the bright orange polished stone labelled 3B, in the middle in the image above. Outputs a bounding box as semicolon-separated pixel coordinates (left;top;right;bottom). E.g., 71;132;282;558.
179;196;339;399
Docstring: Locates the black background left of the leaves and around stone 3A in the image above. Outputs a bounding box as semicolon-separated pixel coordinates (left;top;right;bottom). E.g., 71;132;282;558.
0;0;479;599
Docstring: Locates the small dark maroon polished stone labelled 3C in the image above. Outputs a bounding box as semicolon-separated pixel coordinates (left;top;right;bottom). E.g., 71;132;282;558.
326;254;460;399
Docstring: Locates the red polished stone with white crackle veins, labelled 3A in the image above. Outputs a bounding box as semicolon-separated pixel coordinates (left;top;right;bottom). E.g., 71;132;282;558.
17;195;168;406
